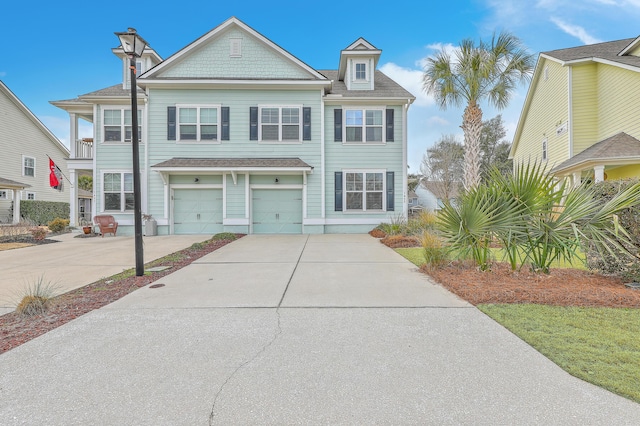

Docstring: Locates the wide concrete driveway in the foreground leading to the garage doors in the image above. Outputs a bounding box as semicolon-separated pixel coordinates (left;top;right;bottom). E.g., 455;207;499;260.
0;235;640;425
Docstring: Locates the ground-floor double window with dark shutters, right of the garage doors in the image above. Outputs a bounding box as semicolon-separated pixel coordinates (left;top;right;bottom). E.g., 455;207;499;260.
344;172;384;211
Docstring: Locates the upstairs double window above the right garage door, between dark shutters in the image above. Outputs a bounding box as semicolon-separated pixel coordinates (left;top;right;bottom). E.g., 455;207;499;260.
260;106;302;142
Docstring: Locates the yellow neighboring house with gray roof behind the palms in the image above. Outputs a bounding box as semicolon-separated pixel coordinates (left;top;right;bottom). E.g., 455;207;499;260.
509;37;640;183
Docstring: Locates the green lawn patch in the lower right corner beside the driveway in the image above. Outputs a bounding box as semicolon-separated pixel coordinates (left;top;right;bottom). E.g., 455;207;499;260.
478;305;640;403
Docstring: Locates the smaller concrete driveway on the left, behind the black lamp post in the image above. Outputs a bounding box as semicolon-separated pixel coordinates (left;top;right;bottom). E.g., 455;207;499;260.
0;233;207;315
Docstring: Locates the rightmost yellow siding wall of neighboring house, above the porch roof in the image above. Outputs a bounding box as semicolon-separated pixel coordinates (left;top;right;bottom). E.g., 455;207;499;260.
594;64;640;142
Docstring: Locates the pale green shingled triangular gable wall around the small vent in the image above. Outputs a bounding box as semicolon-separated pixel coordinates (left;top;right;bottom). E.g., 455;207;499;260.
161;29;311;79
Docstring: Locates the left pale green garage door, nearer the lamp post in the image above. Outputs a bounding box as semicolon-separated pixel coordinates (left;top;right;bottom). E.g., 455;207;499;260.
172;188;223;235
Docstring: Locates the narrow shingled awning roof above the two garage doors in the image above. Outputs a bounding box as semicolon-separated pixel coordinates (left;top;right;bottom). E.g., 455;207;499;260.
152;158;313;169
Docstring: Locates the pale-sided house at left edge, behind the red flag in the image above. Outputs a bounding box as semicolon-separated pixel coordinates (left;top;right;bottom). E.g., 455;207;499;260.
0;81;70;223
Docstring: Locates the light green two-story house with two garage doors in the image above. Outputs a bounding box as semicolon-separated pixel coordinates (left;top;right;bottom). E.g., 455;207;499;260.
54;18;414;234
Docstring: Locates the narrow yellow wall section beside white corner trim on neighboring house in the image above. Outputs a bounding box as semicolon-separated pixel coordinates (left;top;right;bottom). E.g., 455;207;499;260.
570;64;599;155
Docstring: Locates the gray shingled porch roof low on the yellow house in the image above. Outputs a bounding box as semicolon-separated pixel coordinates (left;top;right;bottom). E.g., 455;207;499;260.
551;132;640;173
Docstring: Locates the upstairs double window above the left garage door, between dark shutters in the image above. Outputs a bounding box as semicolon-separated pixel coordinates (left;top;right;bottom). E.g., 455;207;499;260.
178;106;220;142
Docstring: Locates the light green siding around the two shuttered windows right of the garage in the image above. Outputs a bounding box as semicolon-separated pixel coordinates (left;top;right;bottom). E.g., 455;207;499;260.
325;105;403;219
